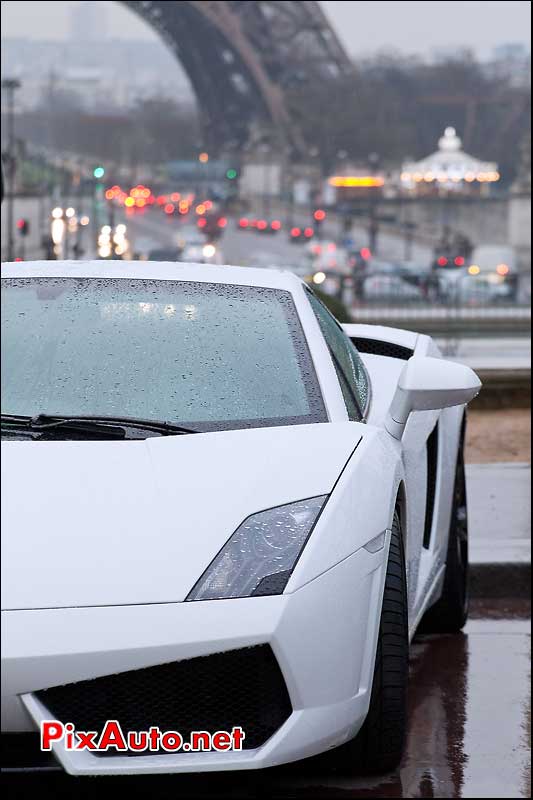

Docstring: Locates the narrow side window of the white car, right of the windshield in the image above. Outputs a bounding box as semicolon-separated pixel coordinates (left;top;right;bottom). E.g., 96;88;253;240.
308;292;369;420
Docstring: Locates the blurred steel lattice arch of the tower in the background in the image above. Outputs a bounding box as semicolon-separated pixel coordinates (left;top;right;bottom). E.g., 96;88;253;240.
123;0;352;154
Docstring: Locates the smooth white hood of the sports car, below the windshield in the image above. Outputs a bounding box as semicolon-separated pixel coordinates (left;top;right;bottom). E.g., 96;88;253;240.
2;422;364;609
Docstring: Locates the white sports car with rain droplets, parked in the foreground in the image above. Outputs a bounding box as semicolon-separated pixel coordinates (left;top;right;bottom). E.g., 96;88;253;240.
2;262;480;775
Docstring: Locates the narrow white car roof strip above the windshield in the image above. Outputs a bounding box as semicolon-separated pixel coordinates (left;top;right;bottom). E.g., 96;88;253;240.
2;260;303;292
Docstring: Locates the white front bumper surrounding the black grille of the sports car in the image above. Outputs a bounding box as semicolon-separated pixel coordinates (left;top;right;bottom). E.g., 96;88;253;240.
2;537;389;775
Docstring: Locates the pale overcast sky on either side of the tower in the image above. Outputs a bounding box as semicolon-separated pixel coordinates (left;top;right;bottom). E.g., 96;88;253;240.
2;0;531;56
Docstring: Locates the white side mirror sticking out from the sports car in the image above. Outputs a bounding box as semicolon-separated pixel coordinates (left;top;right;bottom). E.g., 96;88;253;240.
385;356;481;439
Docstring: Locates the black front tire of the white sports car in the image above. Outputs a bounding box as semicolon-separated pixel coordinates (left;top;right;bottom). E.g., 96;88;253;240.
329;512;409;774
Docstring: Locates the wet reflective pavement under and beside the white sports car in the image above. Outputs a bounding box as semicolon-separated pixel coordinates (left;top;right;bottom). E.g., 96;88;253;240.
4;600;531;800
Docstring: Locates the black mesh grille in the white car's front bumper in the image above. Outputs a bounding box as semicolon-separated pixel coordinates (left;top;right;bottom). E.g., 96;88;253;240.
37;645;292;754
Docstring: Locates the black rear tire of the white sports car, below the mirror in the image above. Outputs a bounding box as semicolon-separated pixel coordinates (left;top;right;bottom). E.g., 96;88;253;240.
420;440;469;633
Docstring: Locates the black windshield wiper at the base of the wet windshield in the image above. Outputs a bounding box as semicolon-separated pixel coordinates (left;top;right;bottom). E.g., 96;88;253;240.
1;414;200;438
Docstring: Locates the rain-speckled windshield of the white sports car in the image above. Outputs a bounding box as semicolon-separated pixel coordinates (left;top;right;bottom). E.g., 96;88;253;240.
2;278;327;430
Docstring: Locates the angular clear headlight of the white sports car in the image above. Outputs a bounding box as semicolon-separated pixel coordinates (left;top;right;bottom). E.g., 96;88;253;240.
186;495;327;600
